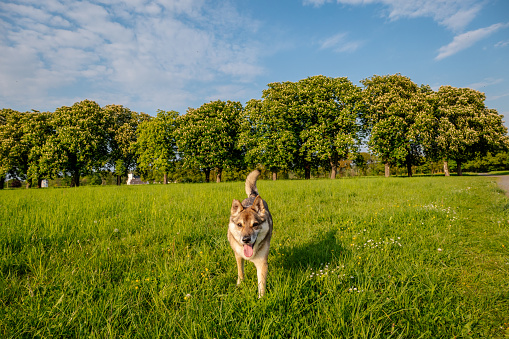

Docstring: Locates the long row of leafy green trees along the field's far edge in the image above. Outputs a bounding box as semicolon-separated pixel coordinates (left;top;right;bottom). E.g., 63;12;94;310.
0;74;509;186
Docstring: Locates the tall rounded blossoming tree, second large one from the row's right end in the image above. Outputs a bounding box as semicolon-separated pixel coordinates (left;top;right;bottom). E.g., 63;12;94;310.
362;74;432;177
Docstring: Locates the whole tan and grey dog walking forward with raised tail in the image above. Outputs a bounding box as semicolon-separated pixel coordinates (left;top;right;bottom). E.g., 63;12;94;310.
228;170;272;298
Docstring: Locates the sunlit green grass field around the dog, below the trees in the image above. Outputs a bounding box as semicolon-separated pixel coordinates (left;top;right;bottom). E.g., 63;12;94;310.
0;177;509;338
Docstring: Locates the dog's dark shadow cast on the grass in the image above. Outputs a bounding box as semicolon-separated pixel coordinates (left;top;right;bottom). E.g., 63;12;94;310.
276;230;350;269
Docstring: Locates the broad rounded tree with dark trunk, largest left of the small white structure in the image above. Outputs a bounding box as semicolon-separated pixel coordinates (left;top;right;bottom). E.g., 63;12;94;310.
40;100;111;187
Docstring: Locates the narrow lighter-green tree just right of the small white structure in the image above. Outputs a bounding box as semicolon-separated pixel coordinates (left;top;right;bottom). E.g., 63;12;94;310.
132;110;179;184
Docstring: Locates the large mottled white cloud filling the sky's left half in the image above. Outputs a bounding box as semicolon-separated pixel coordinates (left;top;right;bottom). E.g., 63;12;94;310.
0;0;264;114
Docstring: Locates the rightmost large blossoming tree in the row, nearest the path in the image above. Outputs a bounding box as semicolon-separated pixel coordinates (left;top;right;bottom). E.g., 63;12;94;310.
430;86;508;176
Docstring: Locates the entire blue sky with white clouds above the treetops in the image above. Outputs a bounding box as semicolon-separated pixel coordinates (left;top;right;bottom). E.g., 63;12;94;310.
0;0;509;125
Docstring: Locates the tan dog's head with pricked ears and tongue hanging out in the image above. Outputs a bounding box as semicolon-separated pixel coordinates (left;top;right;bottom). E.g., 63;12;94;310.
229;196;268;258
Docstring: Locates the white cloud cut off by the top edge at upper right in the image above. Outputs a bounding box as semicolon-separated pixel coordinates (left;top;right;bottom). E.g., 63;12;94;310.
303;0;483;31
